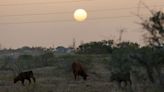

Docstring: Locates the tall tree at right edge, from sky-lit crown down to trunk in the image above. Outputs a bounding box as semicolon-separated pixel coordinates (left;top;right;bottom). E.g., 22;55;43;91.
137;11;164;82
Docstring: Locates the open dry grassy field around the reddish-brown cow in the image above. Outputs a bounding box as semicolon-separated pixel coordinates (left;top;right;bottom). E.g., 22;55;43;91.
0;55;162;92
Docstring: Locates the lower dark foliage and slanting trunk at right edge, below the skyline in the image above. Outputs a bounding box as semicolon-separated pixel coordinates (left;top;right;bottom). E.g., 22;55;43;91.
131;46;164;83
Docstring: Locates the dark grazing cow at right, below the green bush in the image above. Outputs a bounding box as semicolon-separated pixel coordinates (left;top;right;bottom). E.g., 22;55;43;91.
110;72;132;86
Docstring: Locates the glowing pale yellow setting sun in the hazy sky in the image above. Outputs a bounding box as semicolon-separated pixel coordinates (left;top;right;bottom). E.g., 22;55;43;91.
74;9;87;22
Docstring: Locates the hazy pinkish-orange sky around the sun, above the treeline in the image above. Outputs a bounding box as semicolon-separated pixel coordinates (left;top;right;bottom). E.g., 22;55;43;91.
0;0;164;48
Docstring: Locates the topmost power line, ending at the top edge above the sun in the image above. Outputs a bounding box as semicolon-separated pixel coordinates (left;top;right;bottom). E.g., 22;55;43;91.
0;0;93;6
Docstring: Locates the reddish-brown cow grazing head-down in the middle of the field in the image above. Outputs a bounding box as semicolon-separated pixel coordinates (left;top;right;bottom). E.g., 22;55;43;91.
72;62;88;80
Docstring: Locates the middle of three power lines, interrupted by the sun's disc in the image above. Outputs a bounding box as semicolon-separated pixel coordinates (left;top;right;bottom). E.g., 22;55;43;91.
0;5;164;17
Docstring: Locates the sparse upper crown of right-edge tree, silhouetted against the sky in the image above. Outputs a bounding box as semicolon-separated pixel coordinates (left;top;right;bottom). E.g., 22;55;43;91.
141;11;164;47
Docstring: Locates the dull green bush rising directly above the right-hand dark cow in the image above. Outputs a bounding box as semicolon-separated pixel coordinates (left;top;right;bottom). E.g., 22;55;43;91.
110;42;139;73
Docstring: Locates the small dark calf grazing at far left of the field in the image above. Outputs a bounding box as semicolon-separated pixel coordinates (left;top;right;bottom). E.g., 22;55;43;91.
14;71;35;86
